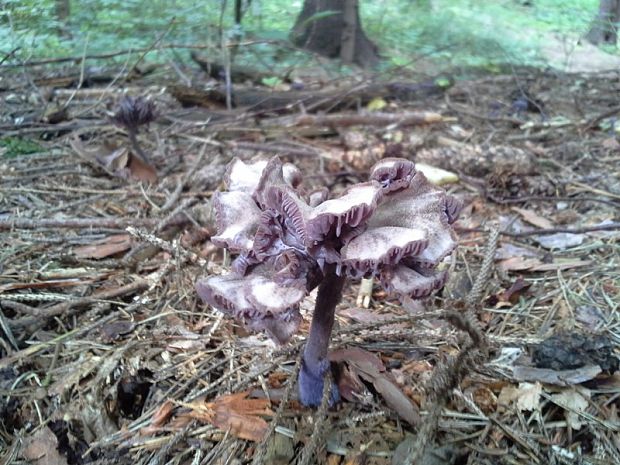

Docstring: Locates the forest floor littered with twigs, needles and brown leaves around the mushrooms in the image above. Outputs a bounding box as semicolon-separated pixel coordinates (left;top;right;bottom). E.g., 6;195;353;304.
0;59;620;465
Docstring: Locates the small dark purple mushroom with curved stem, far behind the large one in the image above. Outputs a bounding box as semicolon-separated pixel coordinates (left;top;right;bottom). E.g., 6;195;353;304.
111;95;157;164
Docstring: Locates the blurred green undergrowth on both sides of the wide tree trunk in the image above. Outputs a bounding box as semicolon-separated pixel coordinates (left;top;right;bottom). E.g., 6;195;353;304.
0;0;612;75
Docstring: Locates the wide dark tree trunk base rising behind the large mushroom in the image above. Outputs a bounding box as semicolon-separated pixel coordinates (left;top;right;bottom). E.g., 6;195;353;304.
291;0;379;68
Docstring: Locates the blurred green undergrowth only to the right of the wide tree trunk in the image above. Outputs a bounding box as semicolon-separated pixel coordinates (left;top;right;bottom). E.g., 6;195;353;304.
362;0;598;71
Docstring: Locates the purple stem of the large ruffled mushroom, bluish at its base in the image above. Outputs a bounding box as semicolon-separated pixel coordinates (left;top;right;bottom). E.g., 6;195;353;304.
299;265;345;406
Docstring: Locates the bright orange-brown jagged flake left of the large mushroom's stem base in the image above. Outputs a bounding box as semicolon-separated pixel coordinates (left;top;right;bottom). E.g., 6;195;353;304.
185;391;273;442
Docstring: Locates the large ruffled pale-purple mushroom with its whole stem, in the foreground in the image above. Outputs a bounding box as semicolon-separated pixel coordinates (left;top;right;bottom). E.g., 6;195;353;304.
196;158;460;406
